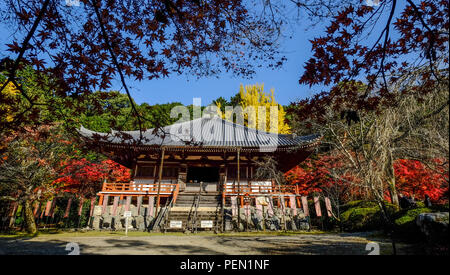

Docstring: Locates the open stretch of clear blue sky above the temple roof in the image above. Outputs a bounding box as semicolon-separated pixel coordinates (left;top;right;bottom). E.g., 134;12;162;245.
117;26;317;105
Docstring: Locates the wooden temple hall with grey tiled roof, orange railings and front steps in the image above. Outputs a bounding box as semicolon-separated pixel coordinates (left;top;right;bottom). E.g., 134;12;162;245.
79;116;320;233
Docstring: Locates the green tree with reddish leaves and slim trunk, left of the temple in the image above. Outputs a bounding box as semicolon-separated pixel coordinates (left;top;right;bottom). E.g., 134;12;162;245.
0;126;73;234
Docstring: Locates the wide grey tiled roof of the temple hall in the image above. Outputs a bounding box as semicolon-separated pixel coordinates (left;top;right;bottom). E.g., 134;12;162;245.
78;116;321;151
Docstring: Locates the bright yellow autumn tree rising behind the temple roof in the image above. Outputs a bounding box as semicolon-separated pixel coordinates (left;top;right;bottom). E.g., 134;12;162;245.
217;84;291;134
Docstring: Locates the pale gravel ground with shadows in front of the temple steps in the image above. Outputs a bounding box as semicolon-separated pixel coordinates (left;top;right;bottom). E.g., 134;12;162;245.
0;233;415;255
